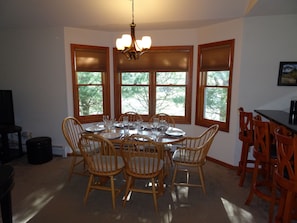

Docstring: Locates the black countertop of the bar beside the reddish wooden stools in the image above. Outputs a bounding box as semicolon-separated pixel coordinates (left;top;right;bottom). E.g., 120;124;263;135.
255;109;297;136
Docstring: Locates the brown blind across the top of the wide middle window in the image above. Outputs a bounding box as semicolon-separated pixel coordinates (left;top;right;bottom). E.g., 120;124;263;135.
114;46;193;72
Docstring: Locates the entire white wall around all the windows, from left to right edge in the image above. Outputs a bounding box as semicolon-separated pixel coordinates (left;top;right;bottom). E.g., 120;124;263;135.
0;15;297;165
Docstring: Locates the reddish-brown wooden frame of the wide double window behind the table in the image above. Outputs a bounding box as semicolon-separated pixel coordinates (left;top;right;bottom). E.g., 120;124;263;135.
113;46;193;124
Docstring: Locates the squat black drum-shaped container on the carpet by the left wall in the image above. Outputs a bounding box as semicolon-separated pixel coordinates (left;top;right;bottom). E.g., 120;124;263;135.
26;136;53;164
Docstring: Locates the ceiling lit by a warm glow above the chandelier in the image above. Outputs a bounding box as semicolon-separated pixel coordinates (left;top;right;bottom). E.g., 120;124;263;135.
0;0;297;31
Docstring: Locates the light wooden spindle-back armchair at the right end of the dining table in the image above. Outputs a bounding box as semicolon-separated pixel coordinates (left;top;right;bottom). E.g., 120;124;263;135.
171;124;219;194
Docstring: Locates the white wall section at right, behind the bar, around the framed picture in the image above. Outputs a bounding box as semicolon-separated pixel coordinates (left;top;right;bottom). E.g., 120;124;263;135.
233;15;297;164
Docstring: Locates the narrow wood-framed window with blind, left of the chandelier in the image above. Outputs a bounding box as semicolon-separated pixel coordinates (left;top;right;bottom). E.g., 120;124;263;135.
71;44;110;123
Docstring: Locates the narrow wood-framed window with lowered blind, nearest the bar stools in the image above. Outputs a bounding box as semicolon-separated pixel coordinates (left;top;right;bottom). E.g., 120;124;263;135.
196;39;234;132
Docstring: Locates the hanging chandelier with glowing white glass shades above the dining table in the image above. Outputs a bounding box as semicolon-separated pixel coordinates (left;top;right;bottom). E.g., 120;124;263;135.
116;0;152;60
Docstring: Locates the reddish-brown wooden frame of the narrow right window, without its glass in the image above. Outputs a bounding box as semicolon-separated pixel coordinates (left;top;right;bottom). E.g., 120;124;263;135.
195;39;235;132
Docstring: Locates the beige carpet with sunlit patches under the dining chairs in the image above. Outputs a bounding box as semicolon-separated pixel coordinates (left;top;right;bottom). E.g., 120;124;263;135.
6;156;269;223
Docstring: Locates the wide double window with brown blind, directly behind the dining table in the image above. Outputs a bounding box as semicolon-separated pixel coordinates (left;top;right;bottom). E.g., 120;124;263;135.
114;46;193;123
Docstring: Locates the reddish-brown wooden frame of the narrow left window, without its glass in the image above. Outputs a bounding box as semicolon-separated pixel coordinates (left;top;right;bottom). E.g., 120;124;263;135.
70;44;110;123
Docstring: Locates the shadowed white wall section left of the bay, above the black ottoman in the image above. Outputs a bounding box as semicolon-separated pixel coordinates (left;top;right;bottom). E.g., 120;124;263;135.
0;28;67;145
